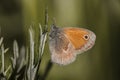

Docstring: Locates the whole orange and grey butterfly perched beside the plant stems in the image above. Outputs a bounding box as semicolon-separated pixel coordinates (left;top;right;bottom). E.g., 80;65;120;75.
49;24;96;65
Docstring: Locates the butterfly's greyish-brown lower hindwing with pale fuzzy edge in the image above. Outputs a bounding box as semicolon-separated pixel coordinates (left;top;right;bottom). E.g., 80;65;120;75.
49;26;76;65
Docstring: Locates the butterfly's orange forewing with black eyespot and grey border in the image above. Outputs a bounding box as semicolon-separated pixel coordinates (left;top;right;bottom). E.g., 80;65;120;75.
63;28;96;53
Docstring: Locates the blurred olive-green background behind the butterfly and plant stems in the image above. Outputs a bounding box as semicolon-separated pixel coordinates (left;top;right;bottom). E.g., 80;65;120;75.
0;0;120;80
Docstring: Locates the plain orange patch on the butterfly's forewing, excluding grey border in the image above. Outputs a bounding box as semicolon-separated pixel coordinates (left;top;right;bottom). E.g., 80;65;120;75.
63;28;88;50
